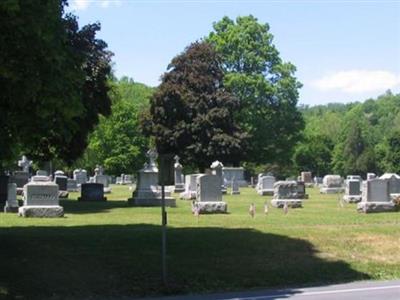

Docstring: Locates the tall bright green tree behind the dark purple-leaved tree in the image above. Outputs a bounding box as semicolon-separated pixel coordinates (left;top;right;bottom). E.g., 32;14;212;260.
207;16;304;163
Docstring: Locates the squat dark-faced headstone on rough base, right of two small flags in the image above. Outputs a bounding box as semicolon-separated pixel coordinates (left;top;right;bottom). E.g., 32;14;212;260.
271;180;303;208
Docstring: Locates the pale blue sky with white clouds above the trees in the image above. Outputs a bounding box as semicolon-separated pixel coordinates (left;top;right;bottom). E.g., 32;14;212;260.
68;0;400;105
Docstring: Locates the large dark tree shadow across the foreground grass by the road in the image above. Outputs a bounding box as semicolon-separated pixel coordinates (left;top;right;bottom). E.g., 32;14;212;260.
0;224;368;299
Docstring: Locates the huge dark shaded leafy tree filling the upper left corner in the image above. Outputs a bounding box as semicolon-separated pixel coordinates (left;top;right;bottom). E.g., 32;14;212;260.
0;0;111;170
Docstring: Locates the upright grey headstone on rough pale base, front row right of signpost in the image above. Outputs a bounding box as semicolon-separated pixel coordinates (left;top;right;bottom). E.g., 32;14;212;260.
193;174;228;214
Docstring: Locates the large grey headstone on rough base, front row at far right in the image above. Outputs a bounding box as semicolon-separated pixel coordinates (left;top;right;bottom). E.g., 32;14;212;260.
357;179;395;213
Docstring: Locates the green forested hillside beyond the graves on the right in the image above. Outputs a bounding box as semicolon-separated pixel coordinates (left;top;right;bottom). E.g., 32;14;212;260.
293;91;400;175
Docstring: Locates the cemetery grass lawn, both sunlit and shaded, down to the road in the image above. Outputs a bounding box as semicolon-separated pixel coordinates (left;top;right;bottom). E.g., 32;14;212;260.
0;186;400;299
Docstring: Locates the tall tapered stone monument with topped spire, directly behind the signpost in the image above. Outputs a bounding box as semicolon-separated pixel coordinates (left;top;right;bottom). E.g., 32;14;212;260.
128;150;176;207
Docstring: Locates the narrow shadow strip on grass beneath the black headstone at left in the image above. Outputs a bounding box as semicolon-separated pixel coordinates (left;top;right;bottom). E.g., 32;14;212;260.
60;199;129;214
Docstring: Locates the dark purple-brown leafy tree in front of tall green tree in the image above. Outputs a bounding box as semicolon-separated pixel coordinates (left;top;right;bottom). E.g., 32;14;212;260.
143;42;247;171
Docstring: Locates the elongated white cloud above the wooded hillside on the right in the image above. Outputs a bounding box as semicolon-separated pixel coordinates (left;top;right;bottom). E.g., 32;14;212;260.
311;70;400;94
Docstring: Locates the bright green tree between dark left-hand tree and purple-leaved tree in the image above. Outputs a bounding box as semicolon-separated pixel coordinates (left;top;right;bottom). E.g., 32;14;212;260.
76;77;153;175
